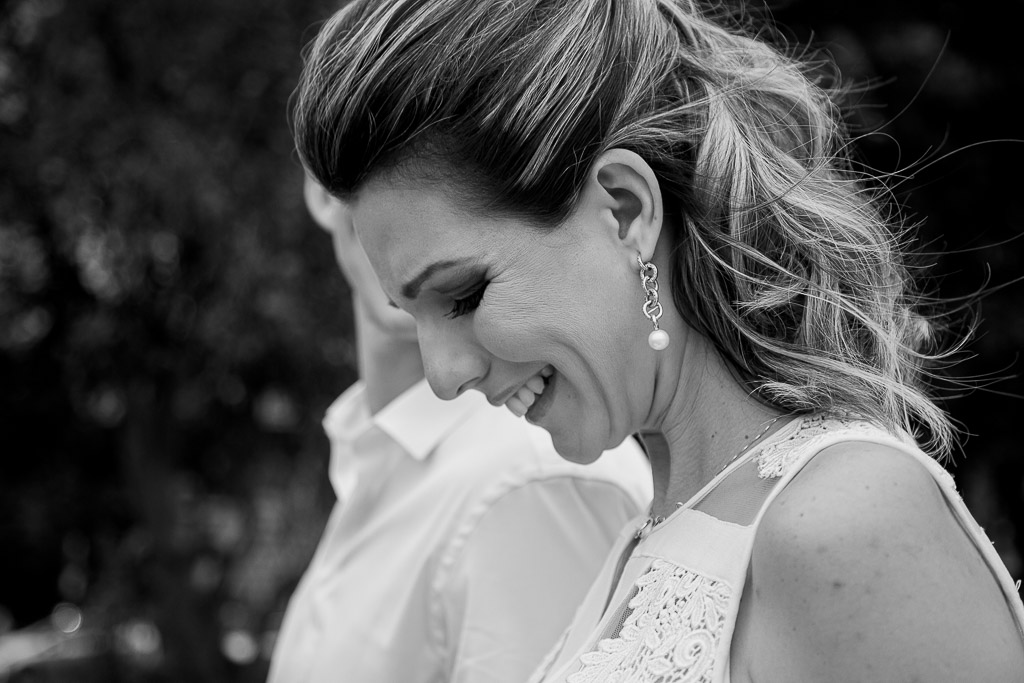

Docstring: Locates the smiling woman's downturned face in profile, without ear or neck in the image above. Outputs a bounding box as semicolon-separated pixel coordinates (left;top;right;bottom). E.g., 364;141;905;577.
350;174;655;463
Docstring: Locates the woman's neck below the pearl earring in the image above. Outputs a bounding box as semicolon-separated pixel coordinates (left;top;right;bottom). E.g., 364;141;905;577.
641;331;782;517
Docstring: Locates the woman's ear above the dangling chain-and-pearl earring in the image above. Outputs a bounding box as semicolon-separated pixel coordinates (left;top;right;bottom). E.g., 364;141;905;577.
591;148;665;261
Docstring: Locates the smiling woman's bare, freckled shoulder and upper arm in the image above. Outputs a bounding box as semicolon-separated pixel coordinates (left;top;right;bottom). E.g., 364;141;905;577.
741;442;1024;681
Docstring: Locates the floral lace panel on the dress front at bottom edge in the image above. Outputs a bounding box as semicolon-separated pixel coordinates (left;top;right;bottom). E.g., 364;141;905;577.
567;560;732;683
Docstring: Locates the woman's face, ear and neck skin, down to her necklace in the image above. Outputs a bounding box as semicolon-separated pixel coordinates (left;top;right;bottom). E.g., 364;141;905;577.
349;150;778;507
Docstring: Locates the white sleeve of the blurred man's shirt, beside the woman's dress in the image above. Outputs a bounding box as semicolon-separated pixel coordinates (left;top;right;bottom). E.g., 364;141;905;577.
435;476;637;683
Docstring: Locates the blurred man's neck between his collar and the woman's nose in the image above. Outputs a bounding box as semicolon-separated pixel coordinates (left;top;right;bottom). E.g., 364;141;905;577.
352;297;424;415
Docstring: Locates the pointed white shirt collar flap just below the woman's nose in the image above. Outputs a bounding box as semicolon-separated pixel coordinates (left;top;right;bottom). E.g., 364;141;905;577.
373;379;486;460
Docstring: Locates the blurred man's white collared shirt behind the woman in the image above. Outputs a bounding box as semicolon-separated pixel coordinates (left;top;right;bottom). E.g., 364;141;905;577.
268;382;651;683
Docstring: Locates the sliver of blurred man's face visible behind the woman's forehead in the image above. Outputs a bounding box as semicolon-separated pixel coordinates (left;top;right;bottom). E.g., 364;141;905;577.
303;176;416;341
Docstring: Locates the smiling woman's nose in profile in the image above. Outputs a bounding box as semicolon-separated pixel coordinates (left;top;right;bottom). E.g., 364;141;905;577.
417;321;487;400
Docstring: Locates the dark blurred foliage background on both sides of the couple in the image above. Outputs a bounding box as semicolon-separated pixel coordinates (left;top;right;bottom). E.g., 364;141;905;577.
0;0;1024;682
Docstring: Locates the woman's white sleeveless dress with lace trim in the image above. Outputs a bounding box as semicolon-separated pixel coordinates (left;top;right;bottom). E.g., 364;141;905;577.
530;416;1024;683
